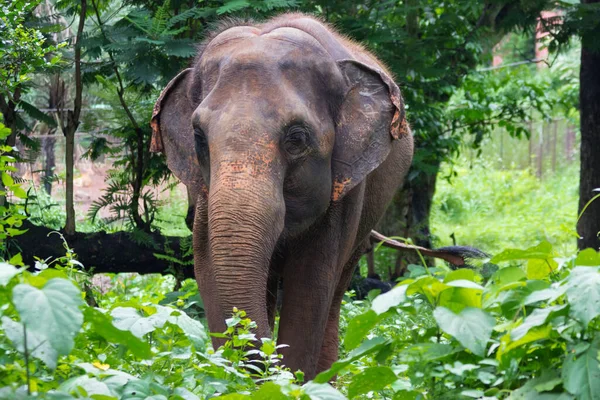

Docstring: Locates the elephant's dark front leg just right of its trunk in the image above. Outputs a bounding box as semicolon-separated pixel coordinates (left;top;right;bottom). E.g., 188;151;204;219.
277;202;360;379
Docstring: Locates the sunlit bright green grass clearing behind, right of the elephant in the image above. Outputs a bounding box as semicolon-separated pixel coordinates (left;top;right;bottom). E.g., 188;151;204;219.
431;159;579;253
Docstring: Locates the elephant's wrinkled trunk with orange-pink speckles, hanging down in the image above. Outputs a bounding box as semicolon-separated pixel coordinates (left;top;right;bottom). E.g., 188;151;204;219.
208;171;285;338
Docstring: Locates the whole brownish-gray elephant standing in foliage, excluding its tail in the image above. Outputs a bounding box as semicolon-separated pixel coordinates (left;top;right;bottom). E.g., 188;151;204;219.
152;14;413;379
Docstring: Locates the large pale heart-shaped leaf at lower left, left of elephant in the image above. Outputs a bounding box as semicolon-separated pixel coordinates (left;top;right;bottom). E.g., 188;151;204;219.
12;278;83;362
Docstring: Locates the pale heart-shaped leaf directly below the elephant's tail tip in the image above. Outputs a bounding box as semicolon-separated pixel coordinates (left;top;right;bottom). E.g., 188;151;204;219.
433;307;496;357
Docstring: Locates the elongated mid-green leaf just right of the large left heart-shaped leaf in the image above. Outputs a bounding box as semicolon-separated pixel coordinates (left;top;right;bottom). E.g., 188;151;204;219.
84;307;152;359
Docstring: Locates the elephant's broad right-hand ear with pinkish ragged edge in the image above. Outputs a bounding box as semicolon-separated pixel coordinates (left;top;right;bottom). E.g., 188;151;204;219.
332;60;409;201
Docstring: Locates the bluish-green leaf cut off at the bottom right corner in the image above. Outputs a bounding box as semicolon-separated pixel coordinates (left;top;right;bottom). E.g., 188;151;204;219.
562;337;600;400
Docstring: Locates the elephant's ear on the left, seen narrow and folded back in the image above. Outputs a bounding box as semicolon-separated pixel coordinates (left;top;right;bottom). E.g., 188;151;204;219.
150;68;204;191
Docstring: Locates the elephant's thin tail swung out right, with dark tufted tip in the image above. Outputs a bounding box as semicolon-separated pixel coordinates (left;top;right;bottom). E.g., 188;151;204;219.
371;230;490;267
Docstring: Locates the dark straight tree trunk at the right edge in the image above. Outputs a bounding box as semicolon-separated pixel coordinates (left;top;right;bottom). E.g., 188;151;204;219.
578;0;600;250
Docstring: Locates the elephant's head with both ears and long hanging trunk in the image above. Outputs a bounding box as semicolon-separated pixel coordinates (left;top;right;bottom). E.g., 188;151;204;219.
152;18;408;344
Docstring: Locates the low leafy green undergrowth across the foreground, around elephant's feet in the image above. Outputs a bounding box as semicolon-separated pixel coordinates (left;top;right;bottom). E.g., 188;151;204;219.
0;223;600;400
